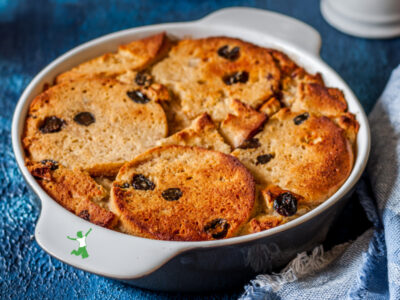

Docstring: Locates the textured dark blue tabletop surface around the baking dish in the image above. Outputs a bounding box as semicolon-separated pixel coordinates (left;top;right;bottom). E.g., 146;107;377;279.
0;0;400;299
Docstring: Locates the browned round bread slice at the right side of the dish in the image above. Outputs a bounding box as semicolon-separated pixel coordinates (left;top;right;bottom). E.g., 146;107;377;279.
232;108;353;204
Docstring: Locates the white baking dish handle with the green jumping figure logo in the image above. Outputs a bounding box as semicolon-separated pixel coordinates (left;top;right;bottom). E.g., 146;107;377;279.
35;194;187;280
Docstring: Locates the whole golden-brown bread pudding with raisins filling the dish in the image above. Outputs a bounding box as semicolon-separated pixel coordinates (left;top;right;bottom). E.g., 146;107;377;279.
22;33;359;241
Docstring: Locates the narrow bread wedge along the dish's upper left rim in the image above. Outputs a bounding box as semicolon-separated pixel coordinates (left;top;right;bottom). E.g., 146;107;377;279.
56;32;171;83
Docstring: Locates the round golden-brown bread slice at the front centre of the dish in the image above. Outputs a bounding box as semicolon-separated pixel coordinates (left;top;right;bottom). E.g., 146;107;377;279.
111;145;255;241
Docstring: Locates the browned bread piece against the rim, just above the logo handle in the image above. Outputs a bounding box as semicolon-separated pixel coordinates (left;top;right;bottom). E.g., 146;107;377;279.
26;160;117;228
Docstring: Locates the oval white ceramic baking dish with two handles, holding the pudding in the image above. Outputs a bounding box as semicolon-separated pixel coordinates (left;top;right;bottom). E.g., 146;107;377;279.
12;8;370;291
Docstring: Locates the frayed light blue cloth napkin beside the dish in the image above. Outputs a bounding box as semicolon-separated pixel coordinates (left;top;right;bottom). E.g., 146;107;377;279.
241;66;400;300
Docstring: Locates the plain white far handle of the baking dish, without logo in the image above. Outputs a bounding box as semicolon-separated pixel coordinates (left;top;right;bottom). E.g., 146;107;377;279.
199;7;321;56
